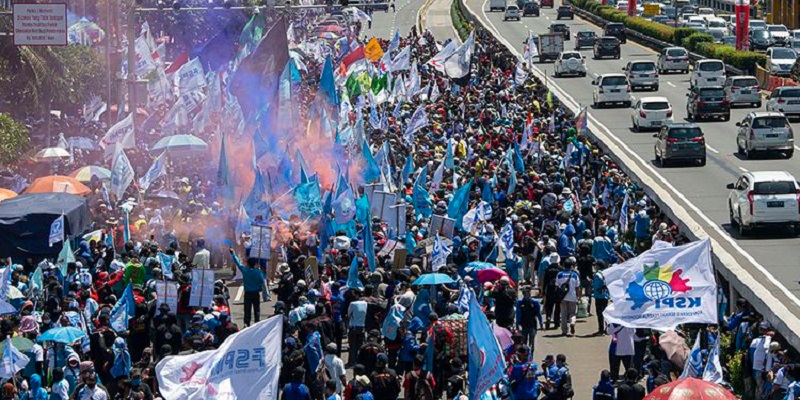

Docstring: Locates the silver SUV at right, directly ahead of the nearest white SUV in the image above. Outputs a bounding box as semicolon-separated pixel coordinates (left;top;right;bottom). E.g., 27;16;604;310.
736;111;794;159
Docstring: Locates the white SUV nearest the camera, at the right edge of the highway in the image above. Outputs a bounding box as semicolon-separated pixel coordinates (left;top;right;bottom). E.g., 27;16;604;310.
726;171;800;236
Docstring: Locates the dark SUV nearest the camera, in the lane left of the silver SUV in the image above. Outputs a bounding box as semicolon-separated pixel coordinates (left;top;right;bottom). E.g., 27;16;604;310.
653;122;706;168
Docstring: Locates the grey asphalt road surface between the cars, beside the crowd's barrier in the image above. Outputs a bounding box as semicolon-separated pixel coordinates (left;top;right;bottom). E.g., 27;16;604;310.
466;0;800;296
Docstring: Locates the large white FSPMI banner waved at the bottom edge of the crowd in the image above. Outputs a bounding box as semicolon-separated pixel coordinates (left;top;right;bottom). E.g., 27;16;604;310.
156;316;283;400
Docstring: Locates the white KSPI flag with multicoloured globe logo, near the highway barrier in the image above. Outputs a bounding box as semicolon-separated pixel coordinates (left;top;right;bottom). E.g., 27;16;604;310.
603;240;718;330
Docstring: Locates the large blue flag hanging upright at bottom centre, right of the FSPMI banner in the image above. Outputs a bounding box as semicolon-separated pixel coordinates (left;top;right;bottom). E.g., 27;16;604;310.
467;290;506;400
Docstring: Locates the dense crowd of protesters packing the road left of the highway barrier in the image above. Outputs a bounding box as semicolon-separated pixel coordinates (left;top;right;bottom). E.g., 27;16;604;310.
0;5;797;400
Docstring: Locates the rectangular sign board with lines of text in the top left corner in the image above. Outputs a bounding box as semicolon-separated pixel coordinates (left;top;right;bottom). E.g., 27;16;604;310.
13;3;67;46
